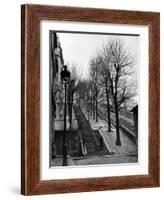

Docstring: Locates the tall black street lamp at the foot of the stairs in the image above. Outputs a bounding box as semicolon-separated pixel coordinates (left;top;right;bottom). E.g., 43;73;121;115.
60;65;70;166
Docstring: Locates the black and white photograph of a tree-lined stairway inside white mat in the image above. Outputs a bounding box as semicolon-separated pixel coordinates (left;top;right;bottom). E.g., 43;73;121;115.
49;30;140;167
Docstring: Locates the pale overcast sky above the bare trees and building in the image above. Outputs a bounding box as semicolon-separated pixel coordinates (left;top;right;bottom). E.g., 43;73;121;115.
57;33;139;78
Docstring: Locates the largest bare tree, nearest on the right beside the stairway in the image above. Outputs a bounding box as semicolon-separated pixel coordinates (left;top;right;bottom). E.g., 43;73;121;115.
103;40;136;146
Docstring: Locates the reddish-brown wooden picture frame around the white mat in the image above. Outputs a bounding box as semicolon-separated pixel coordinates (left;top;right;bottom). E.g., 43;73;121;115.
21;4;160;195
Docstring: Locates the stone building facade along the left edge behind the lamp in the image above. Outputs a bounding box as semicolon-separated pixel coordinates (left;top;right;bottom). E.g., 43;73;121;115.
50;31;64;158
